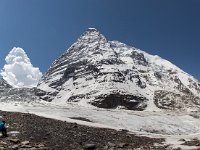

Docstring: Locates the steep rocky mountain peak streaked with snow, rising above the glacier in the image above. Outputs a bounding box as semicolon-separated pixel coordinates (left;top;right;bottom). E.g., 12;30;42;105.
36;28;200;110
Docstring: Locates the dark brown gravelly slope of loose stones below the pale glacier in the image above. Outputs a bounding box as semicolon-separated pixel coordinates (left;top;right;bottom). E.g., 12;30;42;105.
0;111;166;150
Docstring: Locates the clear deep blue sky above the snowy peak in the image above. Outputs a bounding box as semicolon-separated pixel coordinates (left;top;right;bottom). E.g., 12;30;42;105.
0;0;200;80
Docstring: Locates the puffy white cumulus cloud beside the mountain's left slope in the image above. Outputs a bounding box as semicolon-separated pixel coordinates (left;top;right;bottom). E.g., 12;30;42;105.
0;47;42;88
